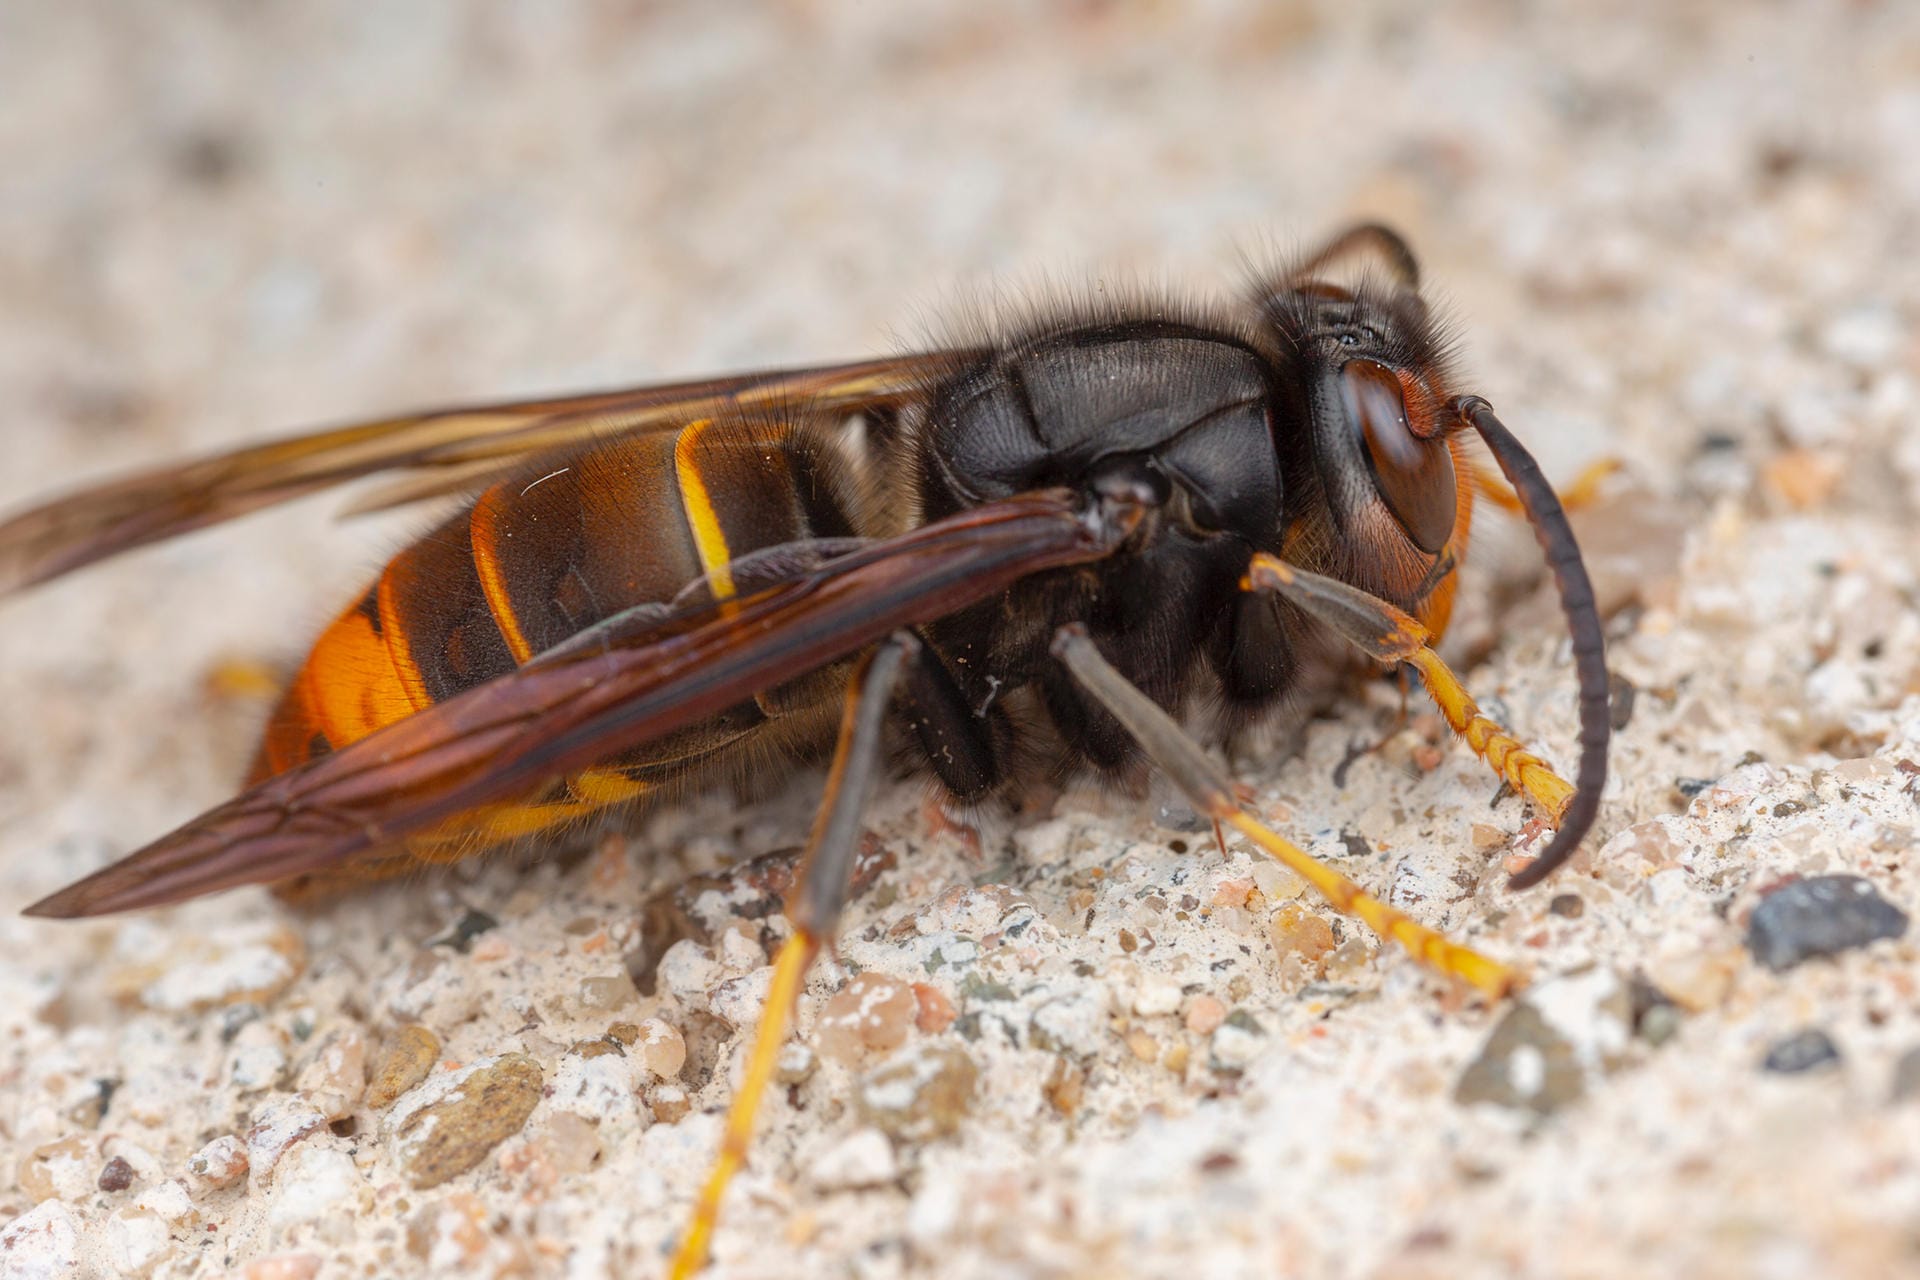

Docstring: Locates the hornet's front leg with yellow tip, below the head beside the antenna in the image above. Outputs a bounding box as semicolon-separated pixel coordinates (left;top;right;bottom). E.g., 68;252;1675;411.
1242;553;1572;825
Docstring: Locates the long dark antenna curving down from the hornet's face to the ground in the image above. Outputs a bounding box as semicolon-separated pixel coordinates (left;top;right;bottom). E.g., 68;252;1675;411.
1453;395;1613;889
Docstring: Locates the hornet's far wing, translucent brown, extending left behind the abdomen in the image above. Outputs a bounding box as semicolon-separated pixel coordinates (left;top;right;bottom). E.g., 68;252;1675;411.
0;353;952;595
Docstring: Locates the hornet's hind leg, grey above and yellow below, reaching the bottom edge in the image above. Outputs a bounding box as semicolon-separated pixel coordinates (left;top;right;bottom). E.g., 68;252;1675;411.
670;631;920;1280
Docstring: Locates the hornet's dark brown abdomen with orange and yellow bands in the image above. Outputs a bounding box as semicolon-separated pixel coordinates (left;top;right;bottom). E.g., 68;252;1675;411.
248;422;858;890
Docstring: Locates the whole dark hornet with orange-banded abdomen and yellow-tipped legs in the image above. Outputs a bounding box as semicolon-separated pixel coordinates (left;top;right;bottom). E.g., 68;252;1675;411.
0;226;1607;1268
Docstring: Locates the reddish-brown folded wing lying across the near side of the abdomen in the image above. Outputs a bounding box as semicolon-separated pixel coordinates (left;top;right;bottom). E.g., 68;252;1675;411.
27;489;1139;917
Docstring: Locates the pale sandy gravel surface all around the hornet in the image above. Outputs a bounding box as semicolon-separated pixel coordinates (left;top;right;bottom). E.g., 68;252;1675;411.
0;0;1920;1280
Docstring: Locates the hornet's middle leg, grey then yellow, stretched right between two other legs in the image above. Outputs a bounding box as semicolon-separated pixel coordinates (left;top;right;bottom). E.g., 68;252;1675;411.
1052;626;1521;1000
